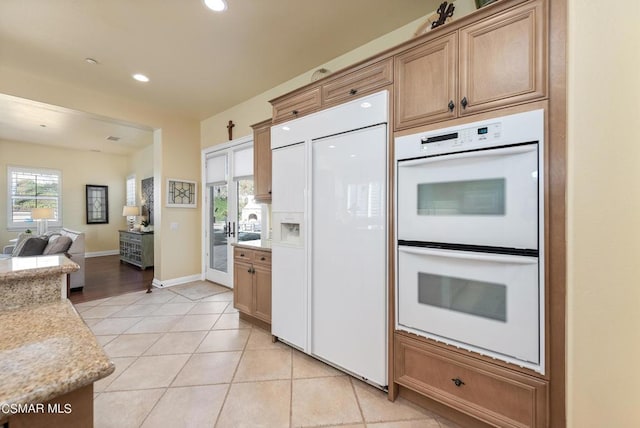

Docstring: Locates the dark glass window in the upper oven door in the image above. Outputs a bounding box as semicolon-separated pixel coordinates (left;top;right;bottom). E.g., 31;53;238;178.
418;178;506;216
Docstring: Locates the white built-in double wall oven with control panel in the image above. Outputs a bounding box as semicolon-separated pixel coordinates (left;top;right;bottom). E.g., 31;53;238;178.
395;110;545;373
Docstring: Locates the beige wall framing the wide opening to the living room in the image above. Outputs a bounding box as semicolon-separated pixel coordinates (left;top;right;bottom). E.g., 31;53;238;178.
0;66;201;282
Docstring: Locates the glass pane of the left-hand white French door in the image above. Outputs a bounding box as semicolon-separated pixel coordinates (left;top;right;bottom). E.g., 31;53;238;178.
209;184;228;272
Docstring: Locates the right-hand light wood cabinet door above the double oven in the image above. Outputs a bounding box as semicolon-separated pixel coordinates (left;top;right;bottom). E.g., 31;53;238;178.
458;0;547;115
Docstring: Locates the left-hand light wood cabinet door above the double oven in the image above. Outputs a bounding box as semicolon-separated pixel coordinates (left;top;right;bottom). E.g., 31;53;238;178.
394;33;459;130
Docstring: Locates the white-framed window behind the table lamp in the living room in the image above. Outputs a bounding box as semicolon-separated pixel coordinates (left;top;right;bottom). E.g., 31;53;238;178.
7;166;62;230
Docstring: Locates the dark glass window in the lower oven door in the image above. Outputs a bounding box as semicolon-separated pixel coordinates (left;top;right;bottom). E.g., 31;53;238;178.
418;272;507;322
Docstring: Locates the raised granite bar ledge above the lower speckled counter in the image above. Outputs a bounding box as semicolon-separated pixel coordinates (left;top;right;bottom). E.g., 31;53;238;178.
0;254;80;282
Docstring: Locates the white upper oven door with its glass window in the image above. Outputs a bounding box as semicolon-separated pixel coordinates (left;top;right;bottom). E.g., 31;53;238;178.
397;143;538;250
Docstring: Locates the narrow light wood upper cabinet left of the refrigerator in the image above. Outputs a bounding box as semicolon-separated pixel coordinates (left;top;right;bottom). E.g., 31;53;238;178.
252;119;271;202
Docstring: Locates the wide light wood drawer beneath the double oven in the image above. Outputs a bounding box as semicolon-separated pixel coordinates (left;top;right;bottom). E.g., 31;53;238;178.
394;333;548;427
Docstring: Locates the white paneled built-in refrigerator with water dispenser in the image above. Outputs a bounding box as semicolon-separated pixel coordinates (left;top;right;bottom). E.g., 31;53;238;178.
271;91;388;386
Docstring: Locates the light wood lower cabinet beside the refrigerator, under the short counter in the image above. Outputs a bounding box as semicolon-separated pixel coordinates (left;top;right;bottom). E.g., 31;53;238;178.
233;247;271;324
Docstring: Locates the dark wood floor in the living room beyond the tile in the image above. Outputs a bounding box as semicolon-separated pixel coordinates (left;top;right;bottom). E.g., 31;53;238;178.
69;255;153;303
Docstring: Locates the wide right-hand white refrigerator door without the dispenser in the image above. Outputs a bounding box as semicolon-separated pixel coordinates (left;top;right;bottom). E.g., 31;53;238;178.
310;124;387;386
